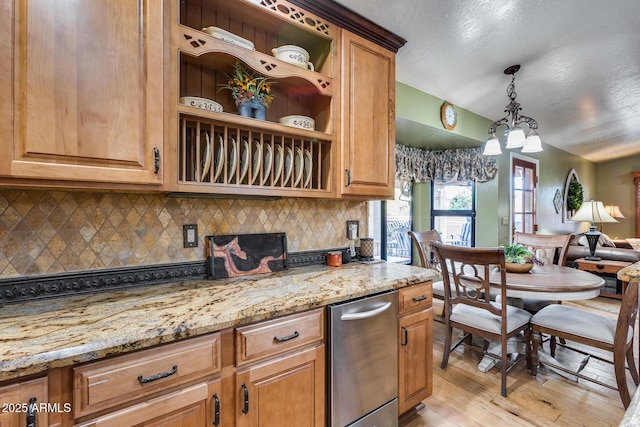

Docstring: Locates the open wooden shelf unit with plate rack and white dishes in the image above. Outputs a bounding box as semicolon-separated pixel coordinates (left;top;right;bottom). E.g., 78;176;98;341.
167;0;339;197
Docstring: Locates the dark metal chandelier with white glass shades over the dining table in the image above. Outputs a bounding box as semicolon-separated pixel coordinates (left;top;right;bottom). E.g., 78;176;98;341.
482;65;542;156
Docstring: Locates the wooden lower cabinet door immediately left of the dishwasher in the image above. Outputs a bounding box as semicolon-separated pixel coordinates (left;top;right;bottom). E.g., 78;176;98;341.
236;345;325;427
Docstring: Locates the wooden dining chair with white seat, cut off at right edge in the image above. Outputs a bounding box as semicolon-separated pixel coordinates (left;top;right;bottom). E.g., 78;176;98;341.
529;283;638;408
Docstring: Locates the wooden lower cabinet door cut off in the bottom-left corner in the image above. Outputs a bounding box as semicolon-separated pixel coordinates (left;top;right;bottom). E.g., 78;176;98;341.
0;377;50;427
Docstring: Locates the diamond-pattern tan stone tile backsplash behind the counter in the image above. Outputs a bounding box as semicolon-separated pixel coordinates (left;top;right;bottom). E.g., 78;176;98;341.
0;190;367;278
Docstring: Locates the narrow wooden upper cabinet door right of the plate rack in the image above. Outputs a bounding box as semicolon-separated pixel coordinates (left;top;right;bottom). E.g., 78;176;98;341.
340;30;396;198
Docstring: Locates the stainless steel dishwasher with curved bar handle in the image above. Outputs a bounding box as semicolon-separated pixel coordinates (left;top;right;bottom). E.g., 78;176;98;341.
327;291;398;427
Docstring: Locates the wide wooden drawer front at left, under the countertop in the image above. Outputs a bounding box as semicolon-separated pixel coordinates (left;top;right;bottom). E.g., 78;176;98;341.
73;333;220;418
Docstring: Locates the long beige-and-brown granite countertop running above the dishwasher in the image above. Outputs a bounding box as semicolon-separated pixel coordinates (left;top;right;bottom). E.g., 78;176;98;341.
0;262;438;381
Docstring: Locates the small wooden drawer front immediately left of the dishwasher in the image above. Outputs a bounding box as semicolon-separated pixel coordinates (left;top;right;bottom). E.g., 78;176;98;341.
236;308;324;366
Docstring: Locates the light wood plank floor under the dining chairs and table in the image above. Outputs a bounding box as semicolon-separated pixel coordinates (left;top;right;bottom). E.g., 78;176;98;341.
400;297;638;427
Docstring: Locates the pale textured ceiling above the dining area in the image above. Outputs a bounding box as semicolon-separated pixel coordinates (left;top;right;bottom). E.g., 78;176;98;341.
336;0;640;162
